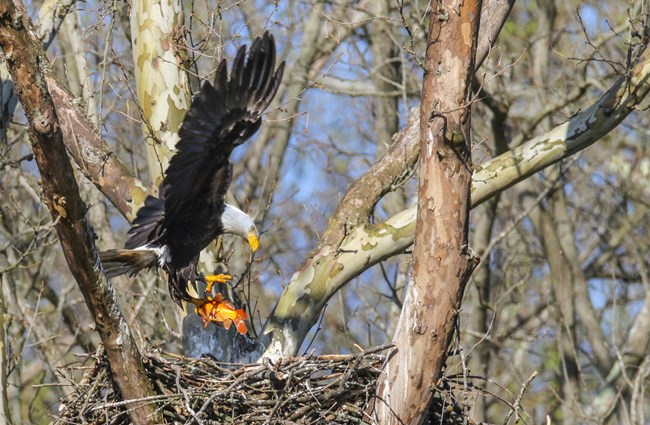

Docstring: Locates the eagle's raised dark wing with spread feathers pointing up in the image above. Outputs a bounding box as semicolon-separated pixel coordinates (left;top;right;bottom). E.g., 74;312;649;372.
163;32;284;223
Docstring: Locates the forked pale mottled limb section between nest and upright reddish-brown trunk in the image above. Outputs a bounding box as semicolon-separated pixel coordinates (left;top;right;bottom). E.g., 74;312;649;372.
261;116;419;359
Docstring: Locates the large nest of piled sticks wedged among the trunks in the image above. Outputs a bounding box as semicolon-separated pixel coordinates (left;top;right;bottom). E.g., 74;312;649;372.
54;346;471;425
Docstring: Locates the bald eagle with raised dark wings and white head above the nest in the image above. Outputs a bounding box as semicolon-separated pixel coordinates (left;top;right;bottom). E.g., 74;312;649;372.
100;32;284;305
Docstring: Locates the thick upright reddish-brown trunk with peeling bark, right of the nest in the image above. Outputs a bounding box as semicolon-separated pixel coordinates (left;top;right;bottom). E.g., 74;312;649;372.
375;0;481;424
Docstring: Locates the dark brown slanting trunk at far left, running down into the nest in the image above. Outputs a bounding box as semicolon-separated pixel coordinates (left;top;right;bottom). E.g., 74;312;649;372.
0;2;160;424
